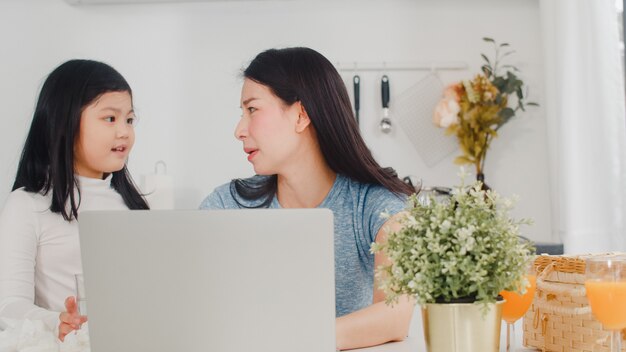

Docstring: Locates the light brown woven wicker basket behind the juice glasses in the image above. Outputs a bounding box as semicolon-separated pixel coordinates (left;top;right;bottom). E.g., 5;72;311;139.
524;253;626;352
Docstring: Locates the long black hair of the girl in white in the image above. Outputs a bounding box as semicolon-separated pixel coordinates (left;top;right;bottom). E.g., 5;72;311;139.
13;60;148;221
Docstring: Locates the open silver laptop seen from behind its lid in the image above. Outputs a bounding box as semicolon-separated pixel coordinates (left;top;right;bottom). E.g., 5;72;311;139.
79;209;336;352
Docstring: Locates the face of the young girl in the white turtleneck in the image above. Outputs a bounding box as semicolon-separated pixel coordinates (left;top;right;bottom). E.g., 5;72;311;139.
74;92;135;179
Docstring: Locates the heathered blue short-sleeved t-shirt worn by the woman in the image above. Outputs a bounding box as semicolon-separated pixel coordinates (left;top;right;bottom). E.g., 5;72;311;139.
200;175;406;317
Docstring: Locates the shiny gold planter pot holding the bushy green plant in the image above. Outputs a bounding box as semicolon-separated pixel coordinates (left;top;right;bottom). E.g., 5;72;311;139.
422;301;504;352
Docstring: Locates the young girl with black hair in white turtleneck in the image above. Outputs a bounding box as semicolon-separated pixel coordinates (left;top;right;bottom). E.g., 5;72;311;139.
0;60;148;339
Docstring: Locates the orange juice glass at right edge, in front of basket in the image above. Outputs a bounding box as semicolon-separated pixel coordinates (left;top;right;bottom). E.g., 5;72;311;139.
585;255;626;352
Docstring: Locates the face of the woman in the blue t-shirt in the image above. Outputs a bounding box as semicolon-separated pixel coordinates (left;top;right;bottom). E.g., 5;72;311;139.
235;78;303;175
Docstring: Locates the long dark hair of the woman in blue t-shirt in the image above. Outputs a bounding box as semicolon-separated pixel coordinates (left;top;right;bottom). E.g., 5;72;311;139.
231;48;414;207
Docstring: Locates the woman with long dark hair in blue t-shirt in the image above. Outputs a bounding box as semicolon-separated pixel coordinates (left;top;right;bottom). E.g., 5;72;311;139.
201;48;413;349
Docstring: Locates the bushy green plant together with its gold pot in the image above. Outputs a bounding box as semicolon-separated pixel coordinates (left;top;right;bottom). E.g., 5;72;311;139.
372;176;533;352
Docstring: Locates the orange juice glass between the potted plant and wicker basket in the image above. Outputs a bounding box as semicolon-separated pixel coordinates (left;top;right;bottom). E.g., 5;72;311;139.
500;258;537;352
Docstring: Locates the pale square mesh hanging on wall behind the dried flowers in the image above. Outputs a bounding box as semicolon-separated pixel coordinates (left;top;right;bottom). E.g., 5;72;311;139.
393;72;458;167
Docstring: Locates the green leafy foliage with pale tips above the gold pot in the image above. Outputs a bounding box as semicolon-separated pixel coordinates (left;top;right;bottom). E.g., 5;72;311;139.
371;173;532;304
